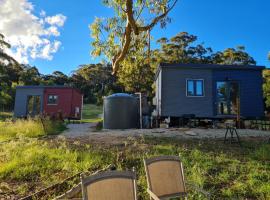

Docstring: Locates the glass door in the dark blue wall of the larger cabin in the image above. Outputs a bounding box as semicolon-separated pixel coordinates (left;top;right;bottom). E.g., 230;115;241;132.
216;81;240;115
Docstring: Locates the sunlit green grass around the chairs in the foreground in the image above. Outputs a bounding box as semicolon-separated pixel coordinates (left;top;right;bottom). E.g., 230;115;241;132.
0;137;270;200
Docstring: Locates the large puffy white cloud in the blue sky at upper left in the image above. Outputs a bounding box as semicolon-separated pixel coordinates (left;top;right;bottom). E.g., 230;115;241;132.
0;0;66;63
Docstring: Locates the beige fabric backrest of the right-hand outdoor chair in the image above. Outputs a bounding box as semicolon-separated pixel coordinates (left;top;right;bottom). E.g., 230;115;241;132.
147;160;186;197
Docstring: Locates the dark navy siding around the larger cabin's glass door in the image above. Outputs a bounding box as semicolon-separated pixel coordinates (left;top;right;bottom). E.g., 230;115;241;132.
213;70;264;117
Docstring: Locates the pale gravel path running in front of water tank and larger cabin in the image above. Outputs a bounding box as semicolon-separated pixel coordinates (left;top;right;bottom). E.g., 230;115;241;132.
61;123;270;139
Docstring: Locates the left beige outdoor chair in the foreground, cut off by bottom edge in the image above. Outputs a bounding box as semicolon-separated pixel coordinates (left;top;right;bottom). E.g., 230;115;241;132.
81;171;137;200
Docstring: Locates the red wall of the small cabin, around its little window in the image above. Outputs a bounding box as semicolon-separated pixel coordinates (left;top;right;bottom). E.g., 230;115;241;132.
43;88;82;118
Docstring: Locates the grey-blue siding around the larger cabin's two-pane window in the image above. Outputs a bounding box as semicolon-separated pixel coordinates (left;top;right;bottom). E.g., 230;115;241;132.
161;68;213;117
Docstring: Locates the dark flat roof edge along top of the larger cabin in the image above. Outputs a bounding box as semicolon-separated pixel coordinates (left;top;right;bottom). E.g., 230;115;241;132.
156;63;265;78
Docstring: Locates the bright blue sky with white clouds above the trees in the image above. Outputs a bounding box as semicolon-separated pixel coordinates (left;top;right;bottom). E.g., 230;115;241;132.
0;0;270;75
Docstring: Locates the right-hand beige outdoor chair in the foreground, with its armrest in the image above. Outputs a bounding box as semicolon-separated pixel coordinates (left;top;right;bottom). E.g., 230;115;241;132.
144;156;210;200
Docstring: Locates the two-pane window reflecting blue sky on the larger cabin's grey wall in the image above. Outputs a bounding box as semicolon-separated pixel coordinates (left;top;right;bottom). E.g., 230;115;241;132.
187;79;204;97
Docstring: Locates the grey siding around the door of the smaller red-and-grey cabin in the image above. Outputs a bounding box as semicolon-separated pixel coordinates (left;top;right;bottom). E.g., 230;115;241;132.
14;88;44;117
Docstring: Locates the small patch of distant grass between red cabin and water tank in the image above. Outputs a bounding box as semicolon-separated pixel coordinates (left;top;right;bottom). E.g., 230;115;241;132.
81;104;103;122
